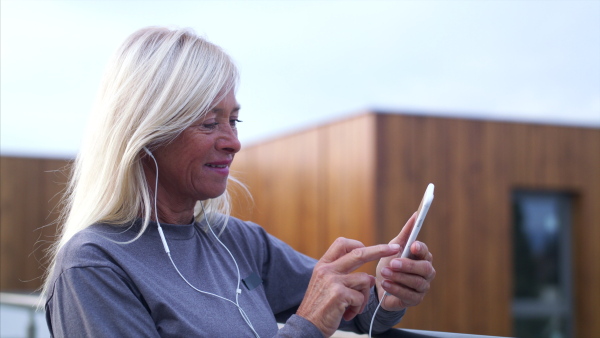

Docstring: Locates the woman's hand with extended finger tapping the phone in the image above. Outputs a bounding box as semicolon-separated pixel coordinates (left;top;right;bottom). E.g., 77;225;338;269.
296;237;400;337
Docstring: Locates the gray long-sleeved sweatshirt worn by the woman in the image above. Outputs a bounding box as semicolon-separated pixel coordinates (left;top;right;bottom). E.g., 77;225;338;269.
46;217;404;337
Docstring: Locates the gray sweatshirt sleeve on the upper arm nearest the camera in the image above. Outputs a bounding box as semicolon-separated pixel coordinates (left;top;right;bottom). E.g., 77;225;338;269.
46;267;159;337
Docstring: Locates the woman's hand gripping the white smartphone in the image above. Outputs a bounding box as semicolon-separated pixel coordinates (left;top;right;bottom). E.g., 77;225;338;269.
377;214;435;311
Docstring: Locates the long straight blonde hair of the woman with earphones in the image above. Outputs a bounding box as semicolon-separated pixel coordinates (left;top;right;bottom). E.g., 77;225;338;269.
42;27;244;295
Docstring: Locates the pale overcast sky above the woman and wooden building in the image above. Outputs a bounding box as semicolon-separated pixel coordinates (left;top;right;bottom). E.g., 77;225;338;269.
0;0;600;157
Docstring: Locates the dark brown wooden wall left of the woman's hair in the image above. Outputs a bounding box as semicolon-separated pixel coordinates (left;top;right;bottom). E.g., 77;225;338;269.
0;156;67;291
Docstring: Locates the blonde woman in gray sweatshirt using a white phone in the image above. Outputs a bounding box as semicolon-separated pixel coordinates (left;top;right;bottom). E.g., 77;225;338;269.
44;27;435;337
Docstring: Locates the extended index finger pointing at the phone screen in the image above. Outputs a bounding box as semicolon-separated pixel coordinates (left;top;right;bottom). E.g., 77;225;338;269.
330;244;400;274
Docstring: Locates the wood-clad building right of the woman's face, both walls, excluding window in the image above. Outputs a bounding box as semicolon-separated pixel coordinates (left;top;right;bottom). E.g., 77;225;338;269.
234;114;600;337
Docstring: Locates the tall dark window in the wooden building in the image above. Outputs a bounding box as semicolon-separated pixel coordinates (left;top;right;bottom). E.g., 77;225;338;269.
512;191;573;338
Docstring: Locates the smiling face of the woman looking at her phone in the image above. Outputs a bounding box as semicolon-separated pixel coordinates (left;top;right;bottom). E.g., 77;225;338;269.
146;90;241;218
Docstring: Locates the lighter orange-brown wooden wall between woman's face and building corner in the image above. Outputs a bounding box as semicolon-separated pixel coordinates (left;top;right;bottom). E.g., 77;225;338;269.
233;115;375;271
